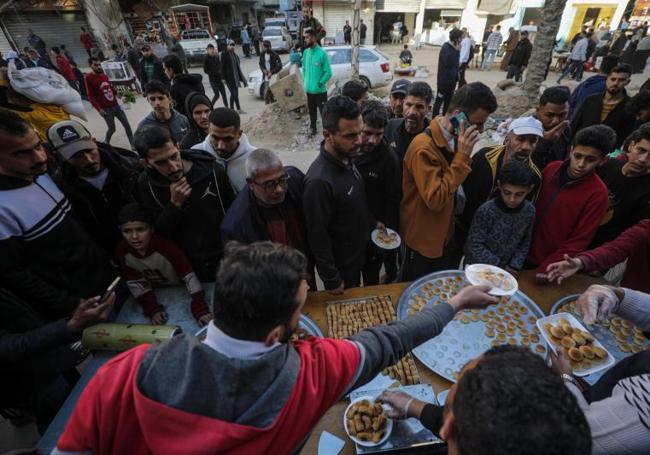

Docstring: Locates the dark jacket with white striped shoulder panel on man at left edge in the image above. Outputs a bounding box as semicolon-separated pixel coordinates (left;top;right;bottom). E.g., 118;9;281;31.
0;175;115;320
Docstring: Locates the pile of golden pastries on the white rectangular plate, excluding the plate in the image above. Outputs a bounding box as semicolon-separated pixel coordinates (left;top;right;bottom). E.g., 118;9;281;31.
544;318;609;372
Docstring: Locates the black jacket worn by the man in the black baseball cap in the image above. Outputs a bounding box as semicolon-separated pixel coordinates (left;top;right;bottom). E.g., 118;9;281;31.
57;143;142;257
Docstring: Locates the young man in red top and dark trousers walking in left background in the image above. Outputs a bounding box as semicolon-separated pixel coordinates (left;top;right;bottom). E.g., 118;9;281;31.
85;57;133;148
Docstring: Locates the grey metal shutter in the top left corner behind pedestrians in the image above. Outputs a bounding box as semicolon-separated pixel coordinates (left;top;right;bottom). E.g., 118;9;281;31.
2;10;88;66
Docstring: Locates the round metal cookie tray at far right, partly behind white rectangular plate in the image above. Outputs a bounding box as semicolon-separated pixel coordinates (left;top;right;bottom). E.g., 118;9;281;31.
551;294;650;360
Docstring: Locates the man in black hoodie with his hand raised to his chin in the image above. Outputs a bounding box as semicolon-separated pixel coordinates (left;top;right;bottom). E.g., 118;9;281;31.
135;126;235;282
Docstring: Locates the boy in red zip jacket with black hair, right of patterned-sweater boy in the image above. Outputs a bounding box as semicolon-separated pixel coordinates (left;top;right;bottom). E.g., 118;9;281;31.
528;125;616;282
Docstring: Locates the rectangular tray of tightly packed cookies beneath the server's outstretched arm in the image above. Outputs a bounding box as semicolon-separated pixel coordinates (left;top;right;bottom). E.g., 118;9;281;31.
326;295;420;387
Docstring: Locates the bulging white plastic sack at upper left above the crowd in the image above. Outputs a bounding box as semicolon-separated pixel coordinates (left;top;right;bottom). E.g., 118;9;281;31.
9;59;86;120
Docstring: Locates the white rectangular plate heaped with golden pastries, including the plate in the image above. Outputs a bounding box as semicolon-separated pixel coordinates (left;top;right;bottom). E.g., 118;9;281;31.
537;313;614;376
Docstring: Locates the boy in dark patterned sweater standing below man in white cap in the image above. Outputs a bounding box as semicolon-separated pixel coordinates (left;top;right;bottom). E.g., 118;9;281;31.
465;161;535;274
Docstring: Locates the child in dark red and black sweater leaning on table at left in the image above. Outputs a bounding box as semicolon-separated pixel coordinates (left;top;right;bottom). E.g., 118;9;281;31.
117;203;212;326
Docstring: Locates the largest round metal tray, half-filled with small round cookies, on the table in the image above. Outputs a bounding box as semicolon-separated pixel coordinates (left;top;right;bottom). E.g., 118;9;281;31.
397;270;547;382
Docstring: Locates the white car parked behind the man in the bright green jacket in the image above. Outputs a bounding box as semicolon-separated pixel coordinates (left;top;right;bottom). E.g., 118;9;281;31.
248;46;393;98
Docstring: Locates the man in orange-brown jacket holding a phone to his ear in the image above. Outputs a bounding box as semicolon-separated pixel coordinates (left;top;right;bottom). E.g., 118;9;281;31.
400;82;497;281
